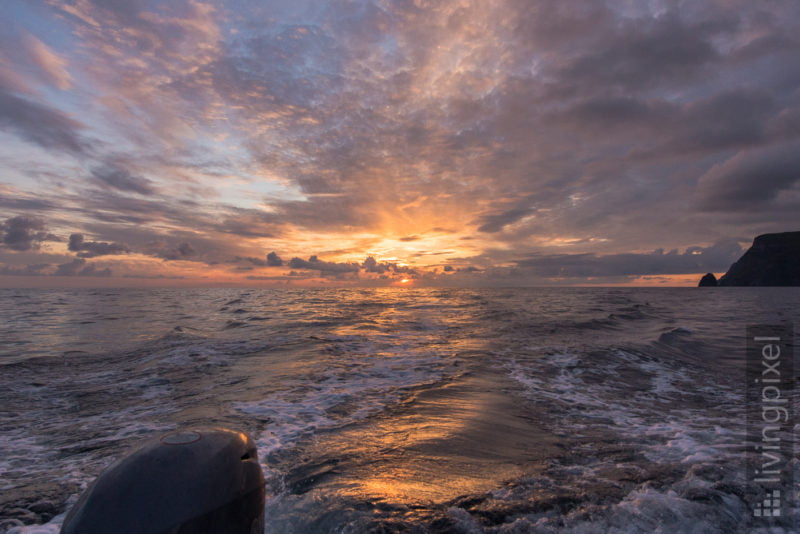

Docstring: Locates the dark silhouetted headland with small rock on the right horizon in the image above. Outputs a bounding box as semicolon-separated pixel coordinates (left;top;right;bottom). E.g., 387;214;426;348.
698;232;800;287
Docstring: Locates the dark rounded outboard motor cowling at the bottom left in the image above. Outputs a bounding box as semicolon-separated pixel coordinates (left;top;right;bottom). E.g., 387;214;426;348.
61;428;264;534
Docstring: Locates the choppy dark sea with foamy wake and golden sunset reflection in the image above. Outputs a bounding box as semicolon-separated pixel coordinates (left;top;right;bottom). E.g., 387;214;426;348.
0;288;800;533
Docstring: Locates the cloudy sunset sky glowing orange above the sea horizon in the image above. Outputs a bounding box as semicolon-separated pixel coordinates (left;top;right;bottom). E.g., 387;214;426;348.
0;0;800;287
